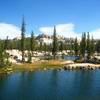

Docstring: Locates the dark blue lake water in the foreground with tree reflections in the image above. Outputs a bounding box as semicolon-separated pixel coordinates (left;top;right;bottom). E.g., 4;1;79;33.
0;70;100;100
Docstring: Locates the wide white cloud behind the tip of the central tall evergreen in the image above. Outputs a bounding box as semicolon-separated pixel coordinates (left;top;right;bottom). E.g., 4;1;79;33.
39;23;80;38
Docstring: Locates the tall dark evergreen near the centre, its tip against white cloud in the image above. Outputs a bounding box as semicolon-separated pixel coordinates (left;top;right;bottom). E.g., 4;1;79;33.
52;27;58;59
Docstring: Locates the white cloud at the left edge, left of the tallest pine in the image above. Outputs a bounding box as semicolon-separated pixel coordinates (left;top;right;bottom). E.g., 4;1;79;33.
0;23;21;39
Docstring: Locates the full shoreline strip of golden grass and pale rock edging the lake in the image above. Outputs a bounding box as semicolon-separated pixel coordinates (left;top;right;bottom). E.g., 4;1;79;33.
0;60;100;74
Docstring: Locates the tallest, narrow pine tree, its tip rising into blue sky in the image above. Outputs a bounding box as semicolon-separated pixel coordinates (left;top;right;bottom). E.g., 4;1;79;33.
21;17;26;62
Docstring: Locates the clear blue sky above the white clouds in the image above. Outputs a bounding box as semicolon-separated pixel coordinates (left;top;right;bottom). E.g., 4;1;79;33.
0;0;100;38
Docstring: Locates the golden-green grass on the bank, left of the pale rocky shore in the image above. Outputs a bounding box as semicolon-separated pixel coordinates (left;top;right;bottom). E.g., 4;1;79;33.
0;60;63;74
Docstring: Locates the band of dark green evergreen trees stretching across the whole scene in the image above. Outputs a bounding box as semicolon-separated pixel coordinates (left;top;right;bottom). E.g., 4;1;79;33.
0;18;100;63
